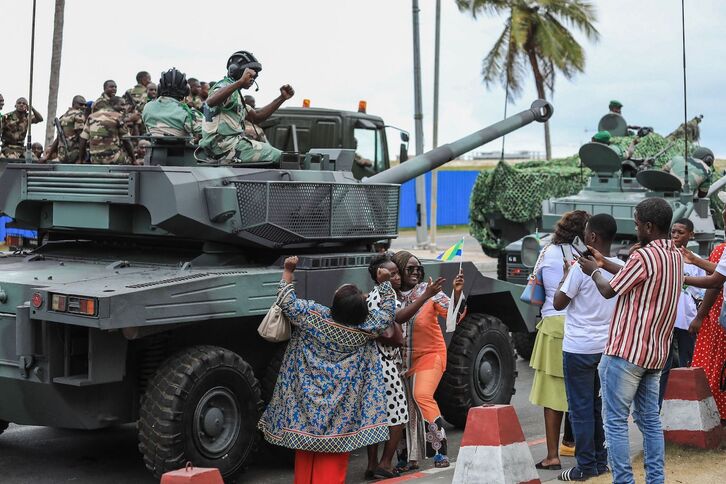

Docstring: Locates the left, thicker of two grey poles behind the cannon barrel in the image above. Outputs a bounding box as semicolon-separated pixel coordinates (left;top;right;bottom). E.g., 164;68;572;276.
411;0;429;249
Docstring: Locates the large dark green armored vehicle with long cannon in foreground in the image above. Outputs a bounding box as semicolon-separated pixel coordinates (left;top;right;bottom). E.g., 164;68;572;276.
0;101;552;476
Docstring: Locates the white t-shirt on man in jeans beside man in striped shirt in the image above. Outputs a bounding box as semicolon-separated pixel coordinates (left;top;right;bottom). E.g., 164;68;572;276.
560;257;623;355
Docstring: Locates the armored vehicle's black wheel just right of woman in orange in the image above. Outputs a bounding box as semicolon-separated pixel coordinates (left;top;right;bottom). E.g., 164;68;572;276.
436;313;517;428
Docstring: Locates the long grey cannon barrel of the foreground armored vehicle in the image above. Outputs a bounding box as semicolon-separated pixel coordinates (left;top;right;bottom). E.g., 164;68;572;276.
363;99;554;184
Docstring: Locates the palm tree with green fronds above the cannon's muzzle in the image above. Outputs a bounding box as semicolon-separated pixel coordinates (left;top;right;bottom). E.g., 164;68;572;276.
455;0;600;160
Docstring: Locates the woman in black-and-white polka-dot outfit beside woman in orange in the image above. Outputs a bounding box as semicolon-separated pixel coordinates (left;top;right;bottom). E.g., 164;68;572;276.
364;253;443;479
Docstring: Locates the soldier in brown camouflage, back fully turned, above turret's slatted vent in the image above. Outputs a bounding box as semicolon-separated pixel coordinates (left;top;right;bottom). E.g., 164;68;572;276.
80;94;134;165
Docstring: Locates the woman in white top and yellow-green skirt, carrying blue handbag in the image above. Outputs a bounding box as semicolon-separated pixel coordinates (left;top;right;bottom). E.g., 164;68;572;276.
529;210;590;470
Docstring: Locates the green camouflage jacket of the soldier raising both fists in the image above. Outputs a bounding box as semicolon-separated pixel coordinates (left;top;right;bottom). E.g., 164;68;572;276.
199;77;247;155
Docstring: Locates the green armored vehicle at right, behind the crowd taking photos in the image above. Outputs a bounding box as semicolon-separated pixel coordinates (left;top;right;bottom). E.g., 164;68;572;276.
498;143;722;359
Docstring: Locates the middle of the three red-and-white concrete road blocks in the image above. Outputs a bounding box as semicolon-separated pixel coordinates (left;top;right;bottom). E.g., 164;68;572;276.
452;405;540;484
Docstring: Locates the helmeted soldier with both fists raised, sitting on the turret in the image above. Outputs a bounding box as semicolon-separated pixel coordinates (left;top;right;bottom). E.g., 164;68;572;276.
199;51;295;163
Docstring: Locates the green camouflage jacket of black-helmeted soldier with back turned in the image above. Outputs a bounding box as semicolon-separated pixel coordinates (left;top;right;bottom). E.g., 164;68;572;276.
142;96;202;139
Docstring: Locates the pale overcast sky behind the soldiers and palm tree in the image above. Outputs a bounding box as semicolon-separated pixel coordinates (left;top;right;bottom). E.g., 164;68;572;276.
0;0;726;158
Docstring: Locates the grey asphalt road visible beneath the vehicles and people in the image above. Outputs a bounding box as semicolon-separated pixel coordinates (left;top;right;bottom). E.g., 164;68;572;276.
0;360;640;484
